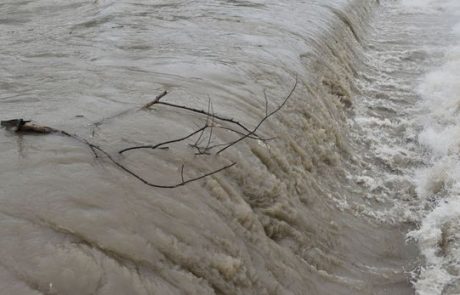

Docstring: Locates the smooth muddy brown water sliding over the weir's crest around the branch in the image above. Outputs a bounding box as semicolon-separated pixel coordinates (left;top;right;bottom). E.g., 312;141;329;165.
0;0;416;295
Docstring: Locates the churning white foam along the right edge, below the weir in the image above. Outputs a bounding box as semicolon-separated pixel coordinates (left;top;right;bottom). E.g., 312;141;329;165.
403;0;460;295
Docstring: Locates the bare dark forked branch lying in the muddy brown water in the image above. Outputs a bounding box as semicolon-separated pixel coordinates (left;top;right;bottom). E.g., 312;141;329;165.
1;77;298;189
